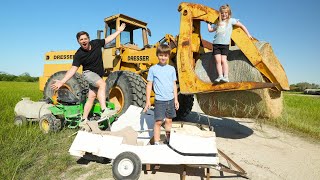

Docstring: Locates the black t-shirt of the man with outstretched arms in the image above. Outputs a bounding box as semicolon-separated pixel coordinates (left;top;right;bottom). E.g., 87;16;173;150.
72;39;105;77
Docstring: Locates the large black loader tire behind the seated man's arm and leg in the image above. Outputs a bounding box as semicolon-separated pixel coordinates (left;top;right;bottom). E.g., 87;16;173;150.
43;71;89;103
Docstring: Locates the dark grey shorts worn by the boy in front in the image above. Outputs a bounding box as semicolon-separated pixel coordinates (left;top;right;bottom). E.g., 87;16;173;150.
154;99;176;121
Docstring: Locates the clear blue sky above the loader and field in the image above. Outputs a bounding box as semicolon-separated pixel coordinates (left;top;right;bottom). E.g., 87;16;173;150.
0;0;320;84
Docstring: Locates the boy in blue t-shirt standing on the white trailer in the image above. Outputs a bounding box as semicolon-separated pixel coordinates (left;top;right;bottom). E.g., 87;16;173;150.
144;44;179;145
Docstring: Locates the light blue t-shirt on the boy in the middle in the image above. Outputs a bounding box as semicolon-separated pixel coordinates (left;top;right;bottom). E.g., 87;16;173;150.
147;64;177;101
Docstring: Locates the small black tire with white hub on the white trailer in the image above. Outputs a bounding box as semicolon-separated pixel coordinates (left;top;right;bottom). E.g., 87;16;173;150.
112;152;142;180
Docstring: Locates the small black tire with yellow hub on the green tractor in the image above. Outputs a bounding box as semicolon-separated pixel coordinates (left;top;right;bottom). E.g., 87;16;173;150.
39;114;61;133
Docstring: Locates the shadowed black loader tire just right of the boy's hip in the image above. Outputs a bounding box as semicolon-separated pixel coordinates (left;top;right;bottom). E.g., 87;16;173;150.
174;94;194;121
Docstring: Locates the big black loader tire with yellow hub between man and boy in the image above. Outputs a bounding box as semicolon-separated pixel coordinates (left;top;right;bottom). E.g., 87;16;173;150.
106;71;146;115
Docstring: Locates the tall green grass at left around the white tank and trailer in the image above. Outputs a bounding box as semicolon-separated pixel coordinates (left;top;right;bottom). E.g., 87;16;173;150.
0;81;111;179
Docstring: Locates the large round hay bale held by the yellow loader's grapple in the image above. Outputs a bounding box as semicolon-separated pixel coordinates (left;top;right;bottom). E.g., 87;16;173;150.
196;46;283;118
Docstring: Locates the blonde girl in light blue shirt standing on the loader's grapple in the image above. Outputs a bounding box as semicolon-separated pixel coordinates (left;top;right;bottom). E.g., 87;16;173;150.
208;4;252;83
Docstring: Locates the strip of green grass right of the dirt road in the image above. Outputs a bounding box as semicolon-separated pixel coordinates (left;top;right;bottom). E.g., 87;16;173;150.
271;92;320;140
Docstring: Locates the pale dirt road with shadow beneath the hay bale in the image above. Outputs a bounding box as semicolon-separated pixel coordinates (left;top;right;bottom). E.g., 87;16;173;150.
140;98;320;180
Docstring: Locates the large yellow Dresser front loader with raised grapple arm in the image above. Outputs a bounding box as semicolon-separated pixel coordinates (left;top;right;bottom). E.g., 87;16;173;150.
40;3;288;117
